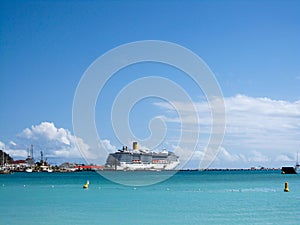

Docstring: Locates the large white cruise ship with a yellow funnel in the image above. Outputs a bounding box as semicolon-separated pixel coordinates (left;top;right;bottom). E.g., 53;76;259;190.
105;142;179;171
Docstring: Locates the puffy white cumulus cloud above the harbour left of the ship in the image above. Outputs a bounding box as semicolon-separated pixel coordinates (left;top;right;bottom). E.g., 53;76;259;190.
0;122;116;164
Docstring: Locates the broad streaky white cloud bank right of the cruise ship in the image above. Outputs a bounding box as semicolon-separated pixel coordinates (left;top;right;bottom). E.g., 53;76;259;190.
155;95;300;166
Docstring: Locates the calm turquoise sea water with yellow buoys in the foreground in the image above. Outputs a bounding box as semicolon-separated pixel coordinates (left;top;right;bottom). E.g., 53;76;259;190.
0;171;300;225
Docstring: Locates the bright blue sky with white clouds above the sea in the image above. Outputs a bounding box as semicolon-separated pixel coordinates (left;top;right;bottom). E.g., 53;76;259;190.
0;0;300;168
